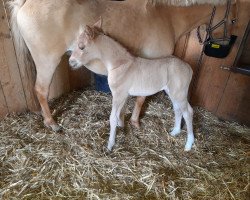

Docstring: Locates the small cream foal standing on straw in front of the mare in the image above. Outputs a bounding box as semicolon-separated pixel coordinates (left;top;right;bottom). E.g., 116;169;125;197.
69;20;194;151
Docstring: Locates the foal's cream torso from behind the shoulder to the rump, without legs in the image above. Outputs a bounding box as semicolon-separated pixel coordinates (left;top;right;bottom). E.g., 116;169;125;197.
127;56;192;96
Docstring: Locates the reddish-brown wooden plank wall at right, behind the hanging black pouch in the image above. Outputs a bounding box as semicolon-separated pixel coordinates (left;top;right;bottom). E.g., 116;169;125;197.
175;1;250;126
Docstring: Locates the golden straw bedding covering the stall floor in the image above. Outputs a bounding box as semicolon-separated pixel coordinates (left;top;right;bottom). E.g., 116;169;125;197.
0;90;250;200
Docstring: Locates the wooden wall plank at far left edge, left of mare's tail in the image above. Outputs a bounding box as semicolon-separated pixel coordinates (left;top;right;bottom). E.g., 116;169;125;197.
0;4;27;112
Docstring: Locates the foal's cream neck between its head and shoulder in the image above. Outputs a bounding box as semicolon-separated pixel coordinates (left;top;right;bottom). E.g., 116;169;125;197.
96;35;134;71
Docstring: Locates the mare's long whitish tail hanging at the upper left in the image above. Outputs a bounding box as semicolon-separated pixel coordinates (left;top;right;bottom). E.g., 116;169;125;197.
7;0;33;65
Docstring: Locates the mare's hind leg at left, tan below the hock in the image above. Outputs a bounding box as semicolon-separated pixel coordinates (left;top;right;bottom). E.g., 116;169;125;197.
34;57;60;131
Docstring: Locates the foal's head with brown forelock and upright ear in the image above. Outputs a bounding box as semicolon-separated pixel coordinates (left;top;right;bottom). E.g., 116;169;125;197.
69;19;102;69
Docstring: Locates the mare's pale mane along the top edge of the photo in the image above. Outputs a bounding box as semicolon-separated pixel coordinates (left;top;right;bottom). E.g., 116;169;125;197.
148;0;227;6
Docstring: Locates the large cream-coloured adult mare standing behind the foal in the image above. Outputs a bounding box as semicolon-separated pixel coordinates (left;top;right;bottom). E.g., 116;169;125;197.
9;0;234;130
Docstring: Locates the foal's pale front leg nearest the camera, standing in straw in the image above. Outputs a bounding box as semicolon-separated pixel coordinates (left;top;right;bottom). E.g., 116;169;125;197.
108;96;127;151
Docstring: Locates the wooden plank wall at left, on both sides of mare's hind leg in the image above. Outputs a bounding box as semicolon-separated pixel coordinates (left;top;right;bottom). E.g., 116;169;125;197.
0;0;90;117
